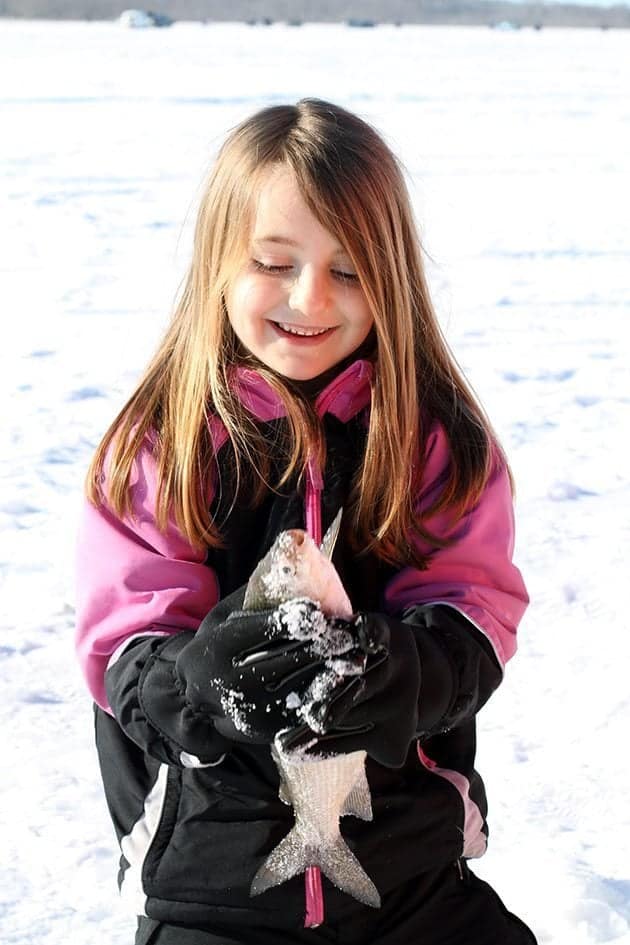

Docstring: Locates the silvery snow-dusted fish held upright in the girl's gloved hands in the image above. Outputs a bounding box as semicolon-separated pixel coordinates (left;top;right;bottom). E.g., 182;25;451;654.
243;510;381;908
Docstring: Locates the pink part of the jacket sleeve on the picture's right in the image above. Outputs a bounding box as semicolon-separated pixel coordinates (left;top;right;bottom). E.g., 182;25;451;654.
385;423;529;668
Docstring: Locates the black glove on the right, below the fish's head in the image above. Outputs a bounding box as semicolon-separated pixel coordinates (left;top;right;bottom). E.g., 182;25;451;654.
282;614;420;768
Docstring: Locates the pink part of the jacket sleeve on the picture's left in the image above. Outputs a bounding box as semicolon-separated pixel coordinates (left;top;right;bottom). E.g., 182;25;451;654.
76;440;219;711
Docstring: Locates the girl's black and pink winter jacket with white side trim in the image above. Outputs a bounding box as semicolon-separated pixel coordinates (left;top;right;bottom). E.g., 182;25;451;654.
77;360;528;934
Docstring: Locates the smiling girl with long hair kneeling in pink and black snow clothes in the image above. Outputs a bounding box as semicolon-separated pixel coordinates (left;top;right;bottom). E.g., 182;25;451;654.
77;99;535;945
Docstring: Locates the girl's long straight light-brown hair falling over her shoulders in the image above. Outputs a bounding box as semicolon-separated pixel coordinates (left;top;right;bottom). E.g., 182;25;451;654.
87;99;505;565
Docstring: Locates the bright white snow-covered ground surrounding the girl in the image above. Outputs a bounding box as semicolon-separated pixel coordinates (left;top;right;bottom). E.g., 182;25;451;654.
0;14;630;945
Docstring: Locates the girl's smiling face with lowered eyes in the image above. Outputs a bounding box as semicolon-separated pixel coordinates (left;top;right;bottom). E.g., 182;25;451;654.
226;167;373;381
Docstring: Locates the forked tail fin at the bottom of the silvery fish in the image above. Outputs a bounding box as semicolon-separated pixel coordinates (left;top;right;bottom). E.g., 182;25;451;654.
250;827;381;909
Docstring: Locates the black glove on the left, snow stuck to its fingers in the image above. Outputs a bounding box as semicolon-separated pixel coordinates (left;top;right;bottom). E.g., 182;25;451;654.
175;587;350;744
